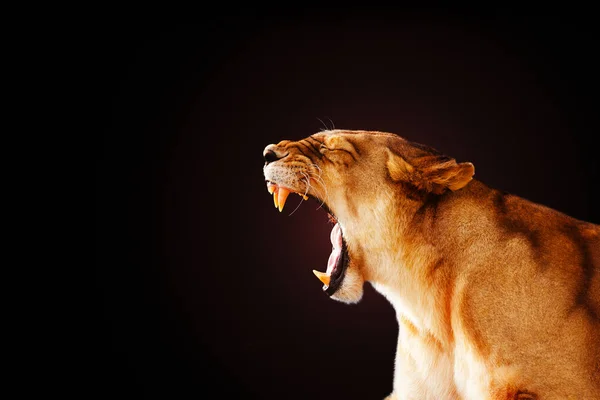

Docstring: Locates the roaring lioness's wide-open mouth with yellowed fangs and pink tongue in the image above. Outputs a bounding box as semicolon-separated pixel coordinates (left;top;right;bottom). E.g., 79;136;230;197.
267;181;350;296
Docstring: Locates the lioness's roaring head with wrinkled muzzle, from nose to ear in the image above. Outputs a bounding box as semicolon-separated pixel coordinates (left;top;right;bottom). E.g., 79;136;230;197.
263;130;473;303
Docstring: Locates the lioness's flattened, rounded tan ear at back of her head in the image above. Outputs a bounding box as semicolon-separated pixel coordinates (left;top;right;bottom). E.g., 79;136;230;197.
387;149;475;194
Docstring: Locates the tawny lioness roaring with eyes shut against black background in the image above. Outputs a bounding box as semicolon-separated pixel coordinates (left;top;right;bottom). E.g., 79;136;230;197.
263;130;600;400
